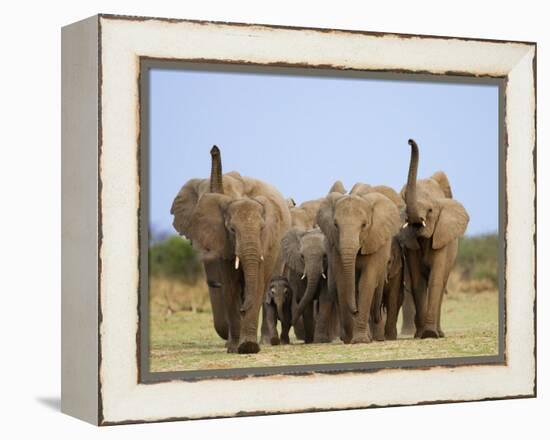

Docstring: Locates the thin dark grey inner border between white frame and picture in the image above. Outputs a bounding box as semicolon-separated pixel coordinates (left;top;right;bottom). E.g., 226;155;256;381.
136;57;507;384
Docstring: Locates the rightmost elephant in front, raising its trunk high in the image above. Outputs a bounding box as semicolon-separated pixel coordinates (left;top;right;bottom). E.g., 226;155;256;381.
401;139;470;338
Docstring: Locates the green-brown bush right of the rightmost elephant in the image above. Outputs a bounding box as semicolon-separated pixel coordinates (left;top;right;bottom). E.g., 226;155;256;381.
456;234;499;288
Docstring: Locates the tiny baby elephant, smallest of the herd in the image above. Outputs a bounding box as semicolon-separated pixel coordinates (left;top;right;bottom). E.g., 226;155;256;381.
264;276;293;345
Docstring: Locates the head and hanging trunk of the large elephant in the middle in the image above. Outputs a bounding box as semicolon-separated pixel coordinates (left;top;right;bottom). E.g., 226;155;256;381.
317;192;400;315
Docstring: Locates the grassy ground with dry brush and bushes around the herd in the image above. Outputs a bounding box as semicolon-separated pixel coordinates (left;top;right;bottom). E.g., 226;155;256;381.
150;235;499;372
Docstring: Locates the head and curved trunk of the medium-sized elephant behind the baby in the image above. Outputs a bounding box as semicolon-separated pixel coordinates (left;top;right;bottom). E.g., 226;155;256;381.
282;228;328;323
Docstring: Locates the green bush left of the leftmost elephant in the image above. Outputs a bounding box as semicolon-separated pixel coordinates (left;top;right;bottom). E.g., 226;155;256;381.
149;235;202;284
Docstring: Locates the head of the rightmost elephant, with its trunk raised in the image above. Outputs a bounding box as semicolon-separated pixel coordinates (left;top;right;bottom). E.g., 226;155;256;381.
401;139;469;249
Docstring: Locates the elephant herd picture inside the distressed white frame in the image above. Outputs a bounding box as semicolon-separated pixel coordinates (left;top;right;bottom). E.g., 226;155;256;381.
140;60;505;378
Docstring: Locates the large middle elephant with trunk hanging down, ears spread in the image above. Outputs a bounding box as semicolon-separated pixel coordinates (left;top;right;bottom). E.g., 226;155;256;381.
317;182;400;343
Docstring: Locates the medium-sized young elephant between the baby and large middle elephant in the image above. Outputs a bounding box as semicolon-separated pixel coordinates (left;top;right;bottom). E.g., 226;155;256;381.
282;228;338;344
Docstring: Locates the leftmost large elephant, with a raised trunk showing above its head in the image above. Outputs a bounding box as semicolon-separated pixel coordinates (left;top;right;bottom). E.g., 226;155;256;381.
171;146;290;353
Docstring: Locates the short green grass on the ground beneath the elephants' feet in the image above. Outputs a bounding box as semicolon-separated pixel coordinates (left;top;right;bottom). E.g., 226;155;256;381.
150;291;498;372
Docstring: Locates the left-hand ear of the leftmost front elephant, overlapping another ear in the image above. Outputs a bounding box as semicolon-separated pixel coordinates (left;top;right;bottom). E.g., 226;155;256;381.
188;193;233;258
